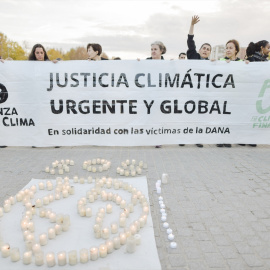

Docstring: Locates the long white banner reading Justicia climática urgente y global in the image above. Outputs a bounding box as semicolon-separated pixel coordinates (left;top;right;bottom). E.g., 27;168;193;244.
0;60;270;147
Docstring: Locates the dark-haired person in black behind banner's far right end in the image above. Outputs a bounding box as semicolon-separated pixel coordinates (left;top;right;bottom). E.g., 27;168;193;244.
246;40;270;62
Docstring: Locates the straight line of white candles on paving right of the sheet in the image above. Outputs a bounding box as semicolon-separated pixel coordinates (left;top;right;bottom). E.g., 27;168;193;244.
156;173;177;248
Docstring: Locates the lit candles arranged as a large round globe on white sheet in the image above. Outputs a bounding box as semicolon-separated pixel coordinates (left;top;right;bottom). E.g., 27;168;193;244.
0;177;149;266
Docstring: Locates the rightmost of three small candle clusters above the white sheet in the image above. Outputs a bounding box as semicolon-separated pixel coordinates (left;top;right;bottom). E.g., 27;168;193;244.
116;159;147;177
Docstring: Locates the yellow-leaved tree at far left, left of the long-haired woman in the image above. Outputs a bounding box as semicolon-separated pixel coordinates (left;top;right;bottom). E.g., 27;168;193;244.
0;33;27;60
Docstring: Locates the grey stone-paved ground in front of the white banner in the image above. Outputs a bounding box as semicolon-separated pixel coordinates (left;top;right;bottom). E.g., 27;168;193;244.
0;145;270;270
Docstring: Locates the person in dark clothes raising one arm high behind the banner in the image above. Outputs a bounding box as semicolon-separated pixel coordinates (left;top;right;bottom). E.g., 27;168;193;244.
187;15;212;147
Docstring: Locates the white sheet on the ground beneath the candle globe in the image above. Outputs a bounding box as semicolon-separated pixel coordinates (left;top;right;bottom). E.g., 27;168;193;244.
0;177;161;270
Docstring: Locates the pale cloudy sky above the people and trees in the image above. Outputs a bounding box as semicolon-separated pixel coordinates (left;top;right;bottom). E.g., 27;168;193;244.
0;0;270;59
